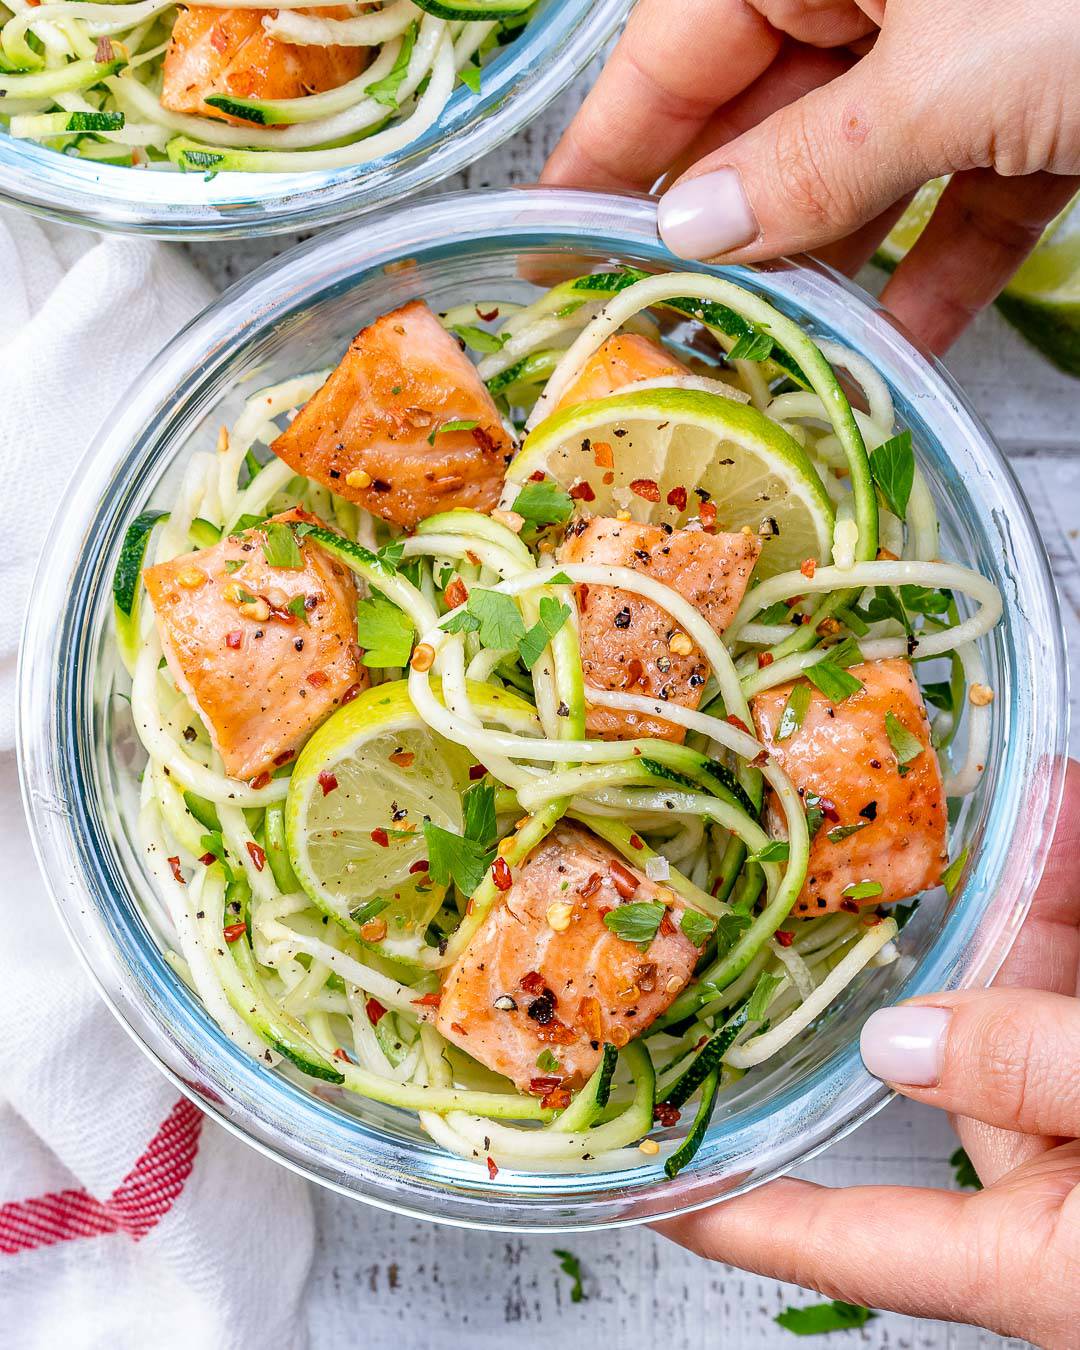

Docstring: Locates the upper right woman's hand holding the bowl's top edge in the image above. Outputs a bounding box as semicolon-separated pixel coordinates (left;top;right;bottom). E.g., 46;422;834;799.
544;0;1080;351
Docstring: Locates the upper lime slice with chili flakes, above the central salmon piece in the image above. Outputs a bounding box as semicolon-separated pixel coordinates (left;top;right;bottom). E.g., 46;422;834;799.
506;389;833;576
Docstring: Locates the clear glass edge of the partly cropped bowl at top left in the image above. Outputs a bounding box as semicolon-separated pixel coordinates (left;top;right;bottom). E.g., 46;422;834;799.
0;0;633;239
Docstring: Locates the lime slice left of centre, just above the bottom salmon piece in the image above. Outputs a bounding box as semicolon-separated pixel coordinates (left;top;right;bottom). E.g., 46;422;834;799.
285;680;536;953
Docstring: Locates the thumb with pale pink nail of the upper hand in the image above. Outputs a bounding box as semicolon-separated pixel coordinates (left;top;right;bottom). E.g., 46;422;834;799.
659;53;949;262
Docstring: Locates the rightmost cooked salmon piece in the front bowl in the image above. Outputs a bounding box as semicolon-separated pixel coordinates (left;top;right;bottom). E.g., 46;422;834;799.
751;660;948;915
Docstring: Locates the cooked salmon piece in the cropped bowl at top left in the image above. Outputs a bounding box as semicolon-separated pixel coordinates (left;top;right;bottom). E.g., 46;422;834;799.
161;5;367;127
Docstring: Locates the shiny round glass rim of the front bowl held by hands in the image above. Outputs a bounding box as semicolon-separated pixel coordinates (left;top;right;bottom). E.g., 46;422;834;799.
19;189;1068;1231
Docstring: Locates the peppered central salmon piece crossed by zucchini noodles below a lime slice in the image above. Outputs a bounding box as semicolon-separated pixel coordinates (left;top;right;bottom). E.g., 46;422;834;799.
559;516;761;741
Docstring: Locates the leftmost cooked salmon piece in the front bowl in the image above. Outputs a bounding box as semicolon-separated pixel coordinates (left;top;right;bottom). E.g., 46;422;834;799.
143;510;370;779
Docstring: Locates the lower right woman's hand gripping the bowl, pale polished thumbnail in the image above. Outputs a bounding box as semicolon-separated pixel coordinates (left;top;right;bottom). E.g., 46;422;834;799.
657;763;1080;1347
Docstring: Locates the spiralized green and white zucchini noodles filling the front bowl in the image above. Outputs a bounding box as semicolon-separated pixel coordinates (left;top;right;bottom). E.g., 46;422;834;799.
114;268;1002;1176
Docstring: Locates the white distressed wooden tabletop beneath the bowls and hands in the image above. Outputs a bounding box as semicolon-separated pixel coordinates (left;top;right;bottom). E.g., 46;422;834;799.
188;76;1080;1350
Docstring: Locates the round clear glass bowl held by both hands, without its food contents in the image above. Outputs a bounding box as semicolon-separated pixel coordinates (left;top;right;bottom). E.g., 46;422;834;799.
20;189;1067;1230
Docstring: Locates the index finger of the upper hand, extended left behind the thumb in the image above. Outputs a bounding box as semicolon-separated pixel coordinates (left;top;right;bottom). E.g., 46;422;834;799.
541;0;782;190
